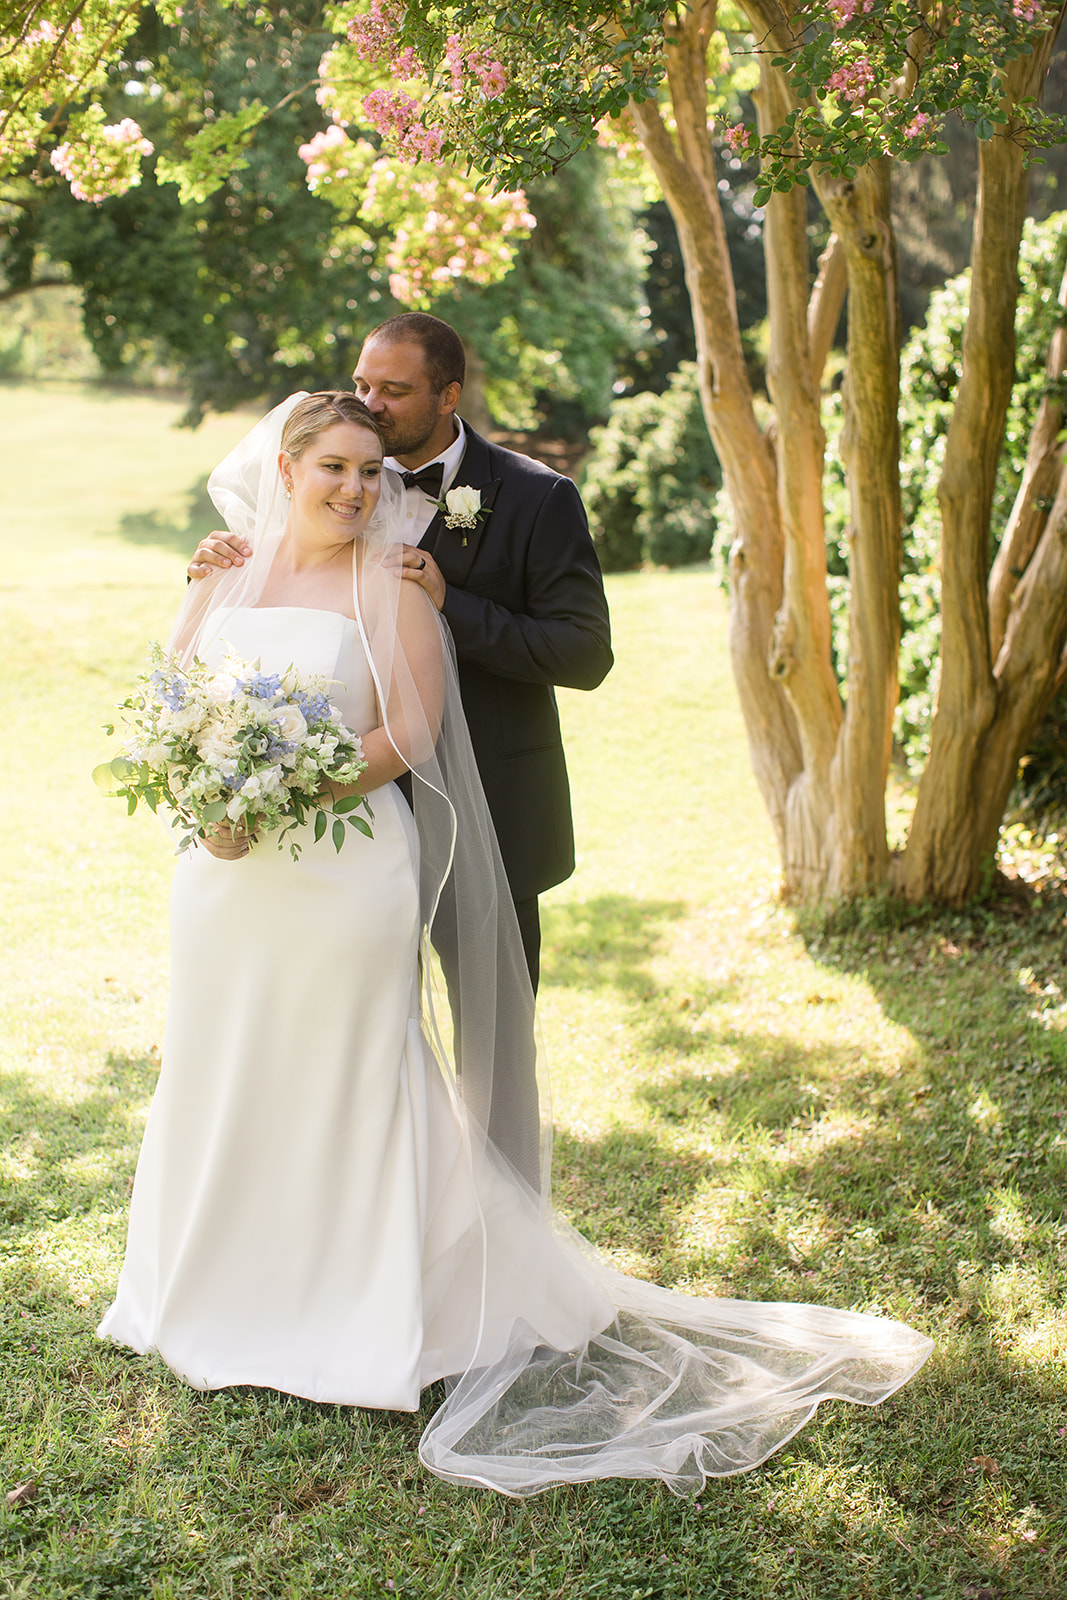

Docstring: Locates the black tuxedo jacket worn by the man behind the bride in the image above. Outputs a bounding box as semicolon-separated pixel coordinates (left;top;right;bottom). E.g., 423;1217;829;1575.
421;424;613;901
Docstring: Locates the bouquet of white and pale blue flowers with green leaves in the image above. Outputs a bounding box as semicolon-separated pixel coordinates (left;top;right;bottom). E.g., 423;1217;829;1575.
93;643;373;859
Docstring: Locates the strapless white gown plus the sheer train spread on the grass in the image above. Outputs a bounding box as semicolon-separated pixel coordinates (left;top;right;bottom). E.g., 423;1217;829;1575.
99;606;931;1494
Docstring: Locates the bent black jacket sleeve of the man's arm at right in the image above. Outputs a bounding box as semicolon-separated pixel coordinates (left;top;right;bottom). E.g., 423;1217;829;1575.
445;478;613;690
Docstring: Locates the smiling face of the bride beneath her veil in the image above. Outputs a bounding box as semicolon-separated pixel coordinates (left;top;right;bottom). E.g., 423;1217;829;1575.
278;422;382;542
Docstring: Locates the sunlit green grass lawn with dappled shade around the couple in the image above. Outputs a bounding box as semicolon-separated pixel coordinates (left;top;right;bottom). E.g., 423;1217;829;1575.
0;386;1067;1600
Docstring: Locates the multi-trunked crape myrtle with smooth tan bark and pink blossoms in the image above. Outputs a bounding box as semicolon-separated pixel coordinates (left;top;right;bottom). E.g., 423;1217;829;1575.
323;0;1067;904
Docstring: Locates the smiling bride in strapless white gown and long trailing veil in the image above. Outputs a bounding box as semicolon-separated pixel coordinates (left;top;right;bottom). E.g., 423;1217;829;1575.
99;392;931;1494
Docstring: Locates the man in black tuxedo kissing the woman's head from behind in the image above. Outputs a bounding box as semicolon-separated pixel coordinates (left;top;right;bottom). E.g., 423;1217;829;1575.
189;312;613;1174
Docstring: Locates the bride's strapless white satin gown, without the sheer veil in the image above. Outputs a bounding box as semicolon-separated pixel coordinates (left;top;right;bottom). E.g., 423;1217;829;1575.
99;606;611;1411
